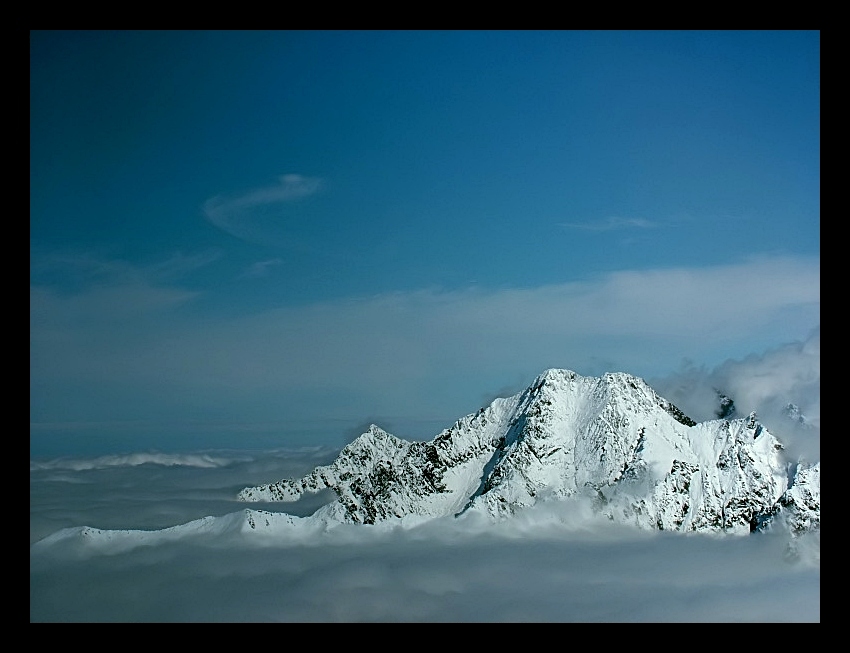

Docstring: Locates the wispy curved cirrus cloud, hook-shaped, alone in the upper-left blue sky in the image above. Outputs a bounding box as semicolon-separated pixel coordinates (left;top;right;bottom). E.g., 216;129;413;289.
203;174;322;243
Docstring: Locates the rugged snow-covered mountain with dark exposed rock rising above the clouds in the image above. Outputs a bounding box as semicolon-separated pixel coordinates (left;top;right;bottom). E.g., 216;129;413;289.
238;369;820;533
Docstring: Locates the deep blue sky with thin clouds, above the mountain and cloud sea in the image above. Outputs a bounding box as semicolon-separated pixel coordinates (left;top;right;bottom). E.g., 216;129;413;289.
30;31;820;455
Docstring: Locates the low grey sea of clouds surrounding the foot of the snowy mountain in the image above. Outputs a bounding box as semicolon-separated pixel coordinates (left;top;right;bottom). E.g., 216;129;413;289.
30;451;820;623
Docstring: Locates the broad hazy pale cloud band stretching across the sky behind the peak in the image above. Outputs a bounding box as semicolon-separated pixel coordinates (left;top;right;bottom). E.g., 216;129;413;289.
30;250;820;448
